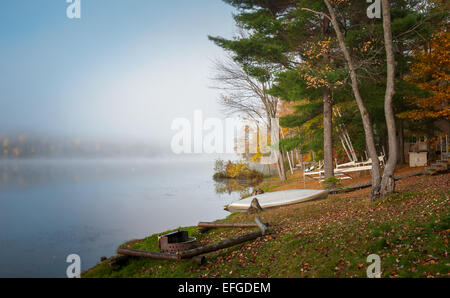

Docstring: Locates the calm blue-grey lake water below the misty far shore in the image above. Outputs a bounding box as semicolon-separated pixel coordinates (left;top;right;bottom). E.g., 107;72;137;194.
0;160;240;277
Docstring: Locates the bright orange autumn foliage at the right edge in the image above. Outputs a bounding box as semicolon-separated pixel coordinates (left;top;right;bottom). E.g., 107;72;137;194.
398;31;450;120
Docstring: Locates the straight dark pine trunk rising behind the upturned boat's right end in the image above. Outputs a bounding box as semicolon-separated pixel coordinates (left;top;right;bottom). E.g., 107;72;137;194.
323;88;334;179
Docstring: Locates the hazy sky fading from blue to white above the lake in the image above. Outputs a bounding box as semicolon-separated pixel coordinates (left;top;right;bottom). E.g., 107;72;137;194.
0;0;235;145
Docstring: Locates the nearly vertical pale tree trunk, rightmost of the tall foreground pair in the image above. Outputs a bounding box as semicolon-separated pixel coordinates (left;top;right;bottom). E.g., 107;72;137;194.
380;0;398;197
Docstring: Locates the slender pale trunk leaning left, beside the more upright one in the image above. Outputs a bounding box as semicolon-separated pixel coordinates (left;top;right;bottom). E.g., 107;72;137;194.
324;0;381;201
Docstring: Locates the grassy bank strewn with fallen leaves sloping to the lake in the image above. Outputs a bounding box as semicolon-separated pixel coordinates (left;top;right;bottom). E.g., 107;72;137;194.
82;174;450;278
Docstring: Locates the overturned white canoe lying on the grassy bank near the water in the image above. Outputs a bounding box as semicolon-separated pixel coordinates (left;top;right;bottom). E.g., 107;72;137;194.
225;189;328;212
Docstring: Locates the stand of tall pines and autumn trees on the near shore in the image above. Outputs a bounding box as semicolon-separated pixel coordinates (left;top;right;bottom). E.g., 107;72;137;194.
209;0;450;200
